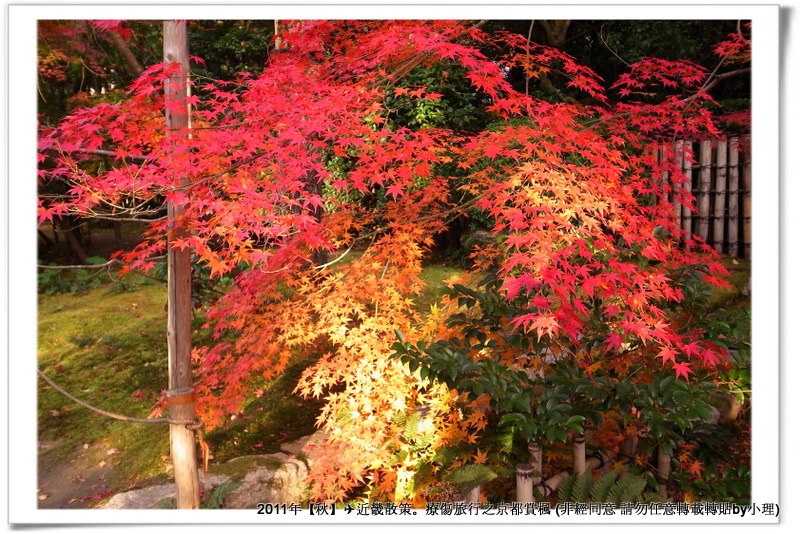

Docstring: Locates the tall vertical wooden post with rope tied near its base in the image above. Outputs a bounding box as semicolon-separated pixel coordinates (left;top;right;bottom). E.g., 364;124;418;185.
164;21;200;509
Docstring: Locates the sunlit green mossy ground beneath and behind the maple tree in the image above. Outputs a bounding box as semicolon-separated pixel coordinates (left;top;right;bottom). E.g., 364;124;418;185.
38;265;472;500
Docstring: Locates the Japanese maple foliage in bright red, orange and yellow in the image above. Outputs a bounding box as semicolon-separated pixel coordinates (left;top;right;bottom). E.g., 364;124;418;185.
39;21;749;500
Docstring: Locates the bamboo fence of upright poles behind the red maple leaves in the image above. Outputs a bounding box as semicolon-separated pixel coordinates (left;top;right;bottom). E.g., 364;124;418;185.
658;135;751;259
